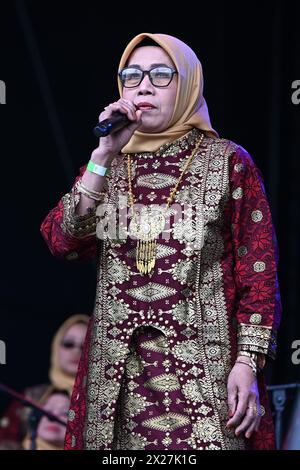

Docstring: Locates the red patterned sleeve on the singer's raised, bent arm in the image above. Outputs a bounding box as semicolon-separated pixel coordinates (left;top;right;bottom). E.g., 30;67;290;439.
41;165;97;261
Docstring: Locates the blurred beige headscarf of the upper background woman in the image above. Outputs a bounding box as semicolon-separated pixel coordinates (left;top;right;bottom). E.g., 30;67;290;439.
49;314;89;393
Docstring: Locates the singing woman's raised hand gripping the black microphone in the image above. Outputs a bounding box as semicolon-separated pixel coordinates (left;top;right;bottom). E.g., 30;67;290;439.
91;98;142;162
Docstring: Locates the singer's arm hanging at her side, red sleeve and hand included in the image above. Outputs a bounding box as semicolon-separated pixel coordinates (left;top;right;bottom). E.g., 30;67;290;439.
228;147;281;437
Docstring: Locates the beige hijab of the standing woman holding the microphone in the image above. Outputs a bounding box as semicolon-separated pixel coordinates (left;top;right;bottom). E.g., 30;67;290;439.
118;33;219;153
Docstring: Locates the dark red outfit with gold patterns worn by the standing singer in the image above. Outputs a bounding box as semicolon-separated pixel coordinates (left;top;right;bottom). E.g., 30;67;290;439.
42;129;281;450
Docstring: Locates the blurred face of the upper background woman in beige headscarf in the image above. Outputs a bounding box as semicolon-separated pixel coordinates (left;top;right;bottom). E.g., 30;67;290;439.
58;323;87;376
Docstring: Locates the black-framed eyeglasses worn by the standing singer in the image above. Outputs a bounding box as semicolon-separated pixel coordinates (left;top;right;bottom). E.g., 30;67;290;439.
119;66;177;88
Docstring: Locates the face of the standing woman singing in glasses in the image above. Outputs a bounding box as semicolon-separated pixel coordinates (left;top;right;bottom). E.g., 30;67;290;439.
123;46;178;133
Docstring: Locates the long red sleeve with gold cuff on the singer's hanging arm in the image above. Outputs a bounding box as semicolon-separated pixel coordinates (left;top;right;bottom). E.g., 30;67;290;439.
230;147;281;358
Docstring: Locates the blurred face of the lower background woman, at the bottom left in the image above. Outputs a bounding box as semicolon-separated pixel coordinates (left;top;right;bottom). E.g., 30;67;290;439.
37;393;70;447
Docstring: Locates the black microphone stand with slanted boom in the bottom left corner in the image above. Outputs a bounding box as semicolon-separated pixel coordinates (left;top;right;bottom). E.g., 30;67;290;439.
0;382;66;450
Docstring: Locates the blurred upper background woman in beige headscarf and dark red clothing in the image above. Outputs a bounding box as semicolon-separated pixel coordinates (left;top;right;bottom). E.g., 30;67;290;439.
0;314;89;450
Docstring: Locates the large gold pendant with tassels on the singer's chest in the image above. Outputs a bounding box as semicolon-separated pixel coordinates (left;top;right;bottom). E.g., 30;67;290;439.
129;206;166;274
